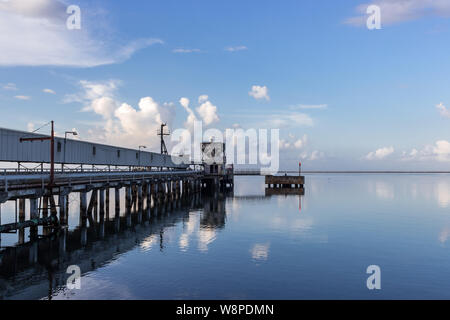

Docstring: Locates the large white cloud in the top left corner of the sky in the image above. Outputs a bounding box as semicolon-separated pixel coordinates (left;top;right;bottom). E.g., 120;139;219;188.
0;0;162;67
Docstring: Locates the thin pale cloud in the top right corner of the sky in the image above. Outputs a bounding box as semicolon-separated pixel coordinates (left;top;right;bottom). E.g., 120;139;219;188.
345;0;450;26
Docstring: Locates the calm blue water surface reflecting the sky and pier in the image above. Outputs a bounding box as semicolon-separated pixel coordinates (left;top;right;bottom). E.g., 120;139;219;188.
0;175;450;299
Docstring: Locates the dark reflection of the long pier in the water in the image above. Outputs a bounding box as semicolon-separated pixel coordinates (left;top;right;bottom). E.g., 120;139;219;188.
0;186;207;299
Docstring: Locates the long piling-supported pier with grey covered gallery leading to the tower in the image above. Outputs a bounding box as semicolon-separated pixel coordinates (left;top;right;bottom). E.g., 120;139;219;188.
0;126;213;239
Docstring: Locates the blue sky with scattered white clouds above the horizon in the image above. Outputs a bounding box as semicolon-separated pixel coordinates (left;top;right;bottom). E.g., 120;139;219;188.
0;0;450;170
